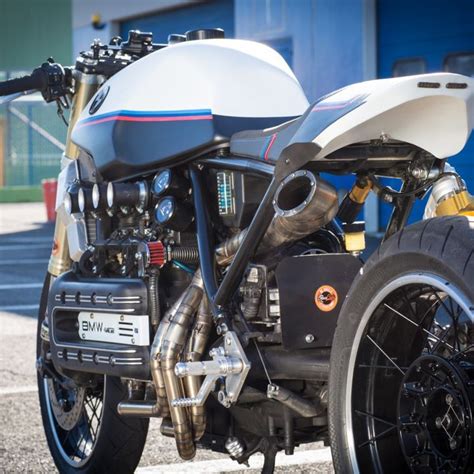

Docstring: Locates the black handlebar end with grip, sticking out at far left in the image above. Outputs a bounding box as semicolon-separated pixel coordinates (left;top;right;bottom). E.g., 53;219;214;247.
0;62;71;102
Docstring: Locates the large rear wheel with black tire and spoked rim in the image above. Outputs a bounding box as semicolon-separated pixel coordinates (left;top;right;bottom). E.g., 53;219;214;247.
329;216;474;474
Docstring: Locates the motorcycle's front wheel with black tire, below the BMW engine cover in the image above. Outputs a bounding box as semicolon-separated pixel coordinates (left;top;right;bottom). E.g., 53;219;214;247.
37;275;149;474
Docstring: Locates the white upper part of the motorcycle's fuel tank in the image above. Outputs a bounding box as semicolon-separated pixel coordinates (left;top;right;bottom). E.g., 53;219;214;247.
81;39;309;118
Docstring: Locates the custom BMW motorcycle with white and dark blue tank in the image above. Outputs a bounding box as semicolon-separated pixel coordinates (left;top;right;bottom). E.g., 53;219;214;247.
0;29;474;473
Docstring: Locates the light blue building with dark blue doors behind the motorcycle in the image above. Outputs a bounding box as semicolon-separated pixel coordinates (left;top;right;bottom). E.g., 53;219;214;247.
0;0;474;230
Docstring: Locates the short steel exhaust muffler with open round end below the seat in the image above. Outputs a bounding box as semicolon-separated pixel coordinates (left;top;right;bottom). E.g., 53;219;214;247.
216;170;339;266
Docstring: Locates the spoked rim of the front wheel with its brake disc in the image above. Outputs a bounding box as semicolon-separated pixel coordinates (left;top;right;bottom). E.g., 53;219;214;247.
43;378;105;468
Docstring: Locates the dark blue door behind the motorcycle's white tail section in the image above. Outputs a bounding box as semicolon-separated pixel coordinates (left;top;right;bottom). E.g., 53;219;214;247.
377;0;474;226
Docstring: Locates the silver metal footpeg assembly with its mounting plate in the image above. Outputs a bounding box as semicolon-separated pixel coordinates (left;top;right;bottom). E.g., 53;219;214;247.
171;331;250;408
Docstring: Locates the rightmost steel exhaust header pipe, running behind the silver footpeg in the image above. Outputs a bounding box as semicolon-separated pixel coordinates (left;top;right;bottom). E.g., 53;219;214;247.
184;295;212;441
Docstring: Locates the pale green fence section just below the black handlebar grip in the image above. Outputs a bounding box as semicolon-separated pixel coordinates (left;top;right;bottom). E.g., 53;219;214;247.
0;74;67;186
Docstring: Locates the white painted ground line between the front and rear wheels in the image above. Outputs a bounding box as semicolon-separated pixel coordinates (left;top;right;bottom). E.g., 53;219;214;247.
135;448;331;474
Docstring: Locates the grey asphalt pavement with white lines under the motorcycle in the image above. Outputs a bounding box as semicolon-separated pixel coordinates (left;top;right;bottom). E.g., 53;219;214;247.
0;203;333;474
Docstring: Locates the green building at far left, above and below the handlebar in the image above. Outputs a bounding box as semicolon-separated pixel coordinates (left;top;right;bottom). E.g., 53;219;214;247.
0;0;72;196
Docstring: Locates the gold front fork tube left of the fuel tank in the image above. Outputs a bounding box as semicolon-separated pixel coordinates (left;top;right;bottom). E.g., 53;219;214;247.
48;71;105;277
